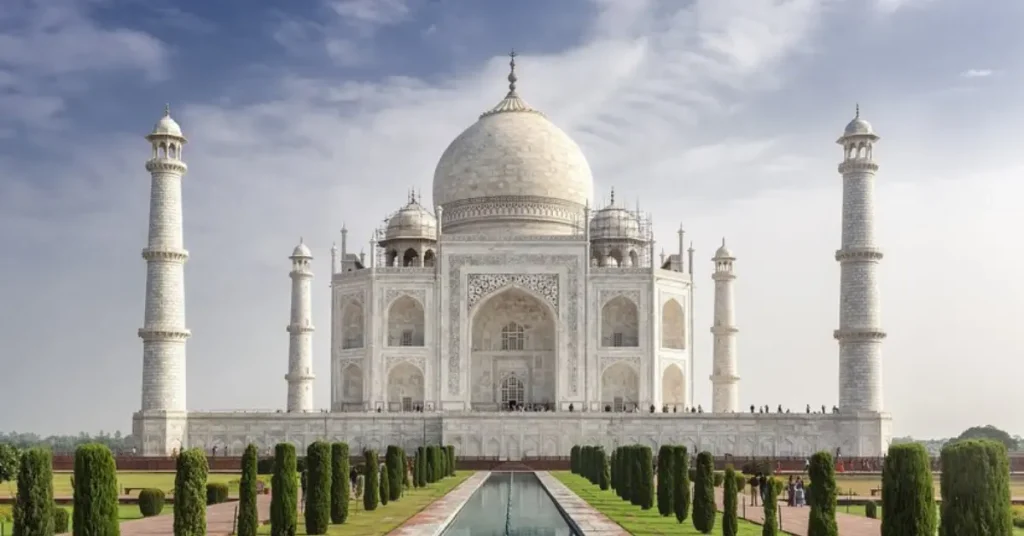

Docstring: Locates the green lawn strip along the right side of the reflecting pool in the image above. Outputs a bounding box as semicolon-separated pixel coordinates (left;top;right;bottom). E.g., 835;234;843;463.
551;471;774;536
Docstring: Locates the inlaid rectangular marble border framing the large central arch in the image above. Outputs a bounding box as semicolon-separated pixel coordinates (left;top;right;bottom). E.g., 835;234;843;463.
446;254;580;396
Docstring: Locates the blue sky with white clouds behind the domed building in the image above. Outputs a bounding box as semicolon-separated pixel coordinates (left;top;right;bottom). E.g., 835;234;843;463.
0;0;1024;438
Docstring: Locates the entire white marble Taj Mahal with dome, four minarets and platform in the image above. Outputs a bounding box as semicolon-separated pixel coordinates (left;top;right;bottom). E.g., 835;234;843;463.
133;53;892;460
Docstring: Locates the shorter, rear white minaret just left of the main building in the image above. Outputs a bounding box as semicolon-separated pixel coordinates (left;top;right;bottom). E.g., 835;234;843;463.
285;239;313;413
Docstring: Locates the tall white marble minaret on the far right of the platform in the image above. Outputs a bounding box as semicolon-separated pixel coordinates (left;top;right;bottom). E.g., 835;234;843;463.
835;106;886;412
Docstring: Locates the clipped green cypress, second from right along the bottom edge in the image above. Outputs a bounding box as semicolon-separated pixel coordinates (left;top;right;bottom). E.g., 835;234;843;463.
882;443;937;536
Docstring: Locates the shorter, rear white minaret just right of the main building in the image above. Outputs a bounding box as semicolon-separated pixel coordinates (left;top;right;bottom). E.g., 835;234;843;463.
711;238;739;413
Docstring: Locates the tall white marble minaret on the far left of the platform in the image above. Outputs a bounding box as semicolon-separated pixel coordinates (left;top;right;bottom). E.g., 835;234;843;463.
138;106;191;416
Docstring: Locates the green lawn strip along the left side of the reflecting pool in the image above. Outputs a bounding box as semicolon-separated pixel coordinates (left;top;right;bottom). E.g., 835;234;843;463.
253;471;473;536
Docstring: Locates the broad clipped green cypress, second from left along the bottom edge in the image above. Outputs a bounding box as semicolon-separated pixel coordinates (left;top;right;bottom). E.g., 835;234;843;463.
72;443;121;536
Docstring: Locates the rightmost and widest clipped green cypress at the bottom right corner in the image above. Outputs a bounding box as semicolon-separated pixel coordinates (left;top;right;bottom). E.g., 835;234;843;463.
937;440;1013;536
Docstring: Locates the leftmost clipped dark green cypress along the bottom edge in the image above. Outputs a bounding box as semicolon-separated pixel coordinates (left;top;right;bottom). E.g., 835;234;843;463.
14;448;59;536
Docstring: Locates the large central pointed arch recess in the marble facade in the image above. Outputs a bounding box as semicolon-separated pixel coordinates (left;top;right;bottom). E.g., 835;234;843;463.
469;287;558;410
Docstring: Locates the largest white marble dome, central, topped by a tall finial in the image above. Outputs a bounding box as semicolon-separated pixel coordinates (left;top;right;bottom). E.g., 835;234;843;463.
433;67;594;235
